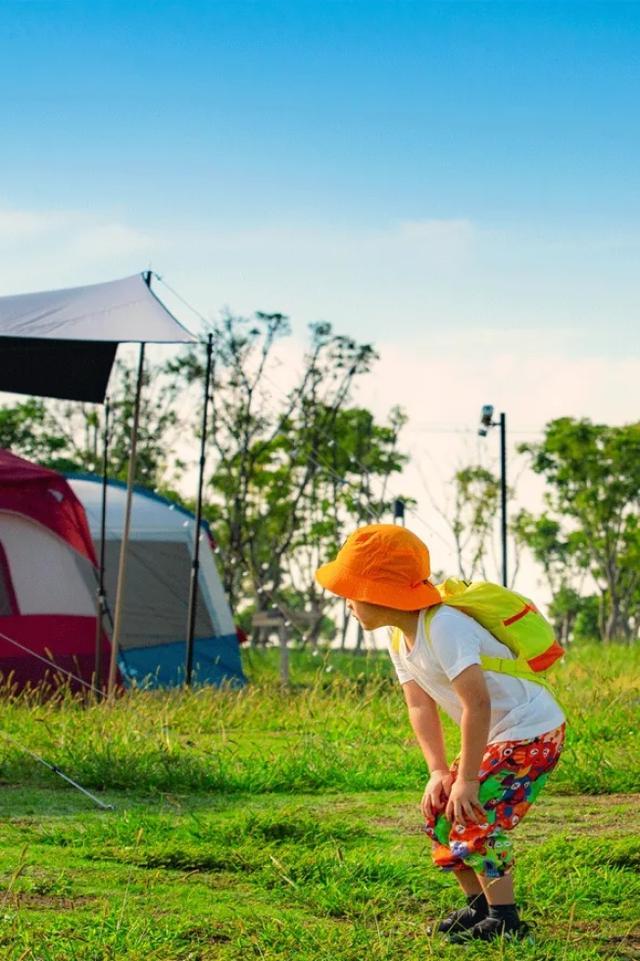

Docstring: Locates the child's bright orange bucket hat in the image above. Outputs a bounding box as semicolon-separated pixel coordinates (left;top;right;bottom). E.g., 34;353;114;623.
316;524;442;611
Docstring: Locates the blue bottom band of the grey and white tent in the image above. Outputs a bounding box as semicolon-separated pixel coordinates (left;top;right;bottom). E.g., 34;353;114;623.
119;634;247;688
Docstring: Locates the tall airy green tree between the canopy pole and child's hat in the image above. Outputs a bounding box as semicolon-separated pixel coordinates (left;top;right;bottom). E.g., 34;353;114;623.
172;314;404;642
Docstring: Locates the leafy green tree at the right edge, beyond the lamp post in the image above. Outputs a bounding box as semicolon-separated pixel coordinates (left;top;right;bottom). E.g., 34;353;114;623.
520;417;640;641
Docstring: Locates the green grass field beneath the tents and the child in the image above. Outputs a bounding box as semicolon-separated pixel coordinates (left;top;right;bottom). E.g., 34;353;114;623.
0;645;640;961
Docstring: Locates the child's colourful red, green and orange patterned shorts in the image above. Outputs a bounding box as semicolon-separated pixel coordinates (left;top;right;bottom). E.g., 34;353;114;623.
425;724;565;878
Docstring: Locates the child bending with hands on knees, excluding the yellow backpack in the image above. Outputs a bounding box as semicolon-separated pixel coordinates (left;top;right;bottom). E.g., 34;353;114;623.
316;524;565;943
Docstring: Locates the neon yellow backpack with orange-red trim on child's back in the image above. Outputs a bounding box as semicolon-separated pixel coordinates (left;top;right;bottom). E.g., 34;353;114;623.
391;577;564;690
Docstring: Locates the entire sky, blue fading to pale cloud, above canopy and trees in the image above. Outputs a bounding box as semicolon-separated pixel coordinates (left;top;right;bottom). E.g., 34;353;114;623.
0;0;640;588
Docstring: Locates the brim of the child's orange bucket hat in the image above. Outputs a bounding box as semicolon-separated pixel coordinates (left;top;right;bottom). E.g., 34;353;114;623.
316;561;442;611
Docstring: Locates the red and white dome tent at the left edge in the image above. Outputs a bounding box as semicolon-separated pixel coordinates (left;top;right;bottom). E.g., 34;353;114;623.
0;450;120;689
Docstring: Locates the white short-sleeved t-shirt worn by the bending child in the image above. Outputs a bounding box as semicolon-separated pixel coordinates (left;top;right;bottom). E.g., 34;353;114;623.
389;604;565;741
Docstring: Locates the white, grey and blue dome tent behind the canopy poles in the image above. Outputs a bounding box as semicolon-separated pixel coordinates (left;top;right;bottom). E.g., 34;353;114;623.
67;474;245;686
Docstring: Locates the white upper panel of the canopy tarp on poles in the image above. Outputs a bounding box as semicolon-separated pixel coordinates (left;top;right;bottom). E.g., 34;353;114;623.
0;274;195;346
